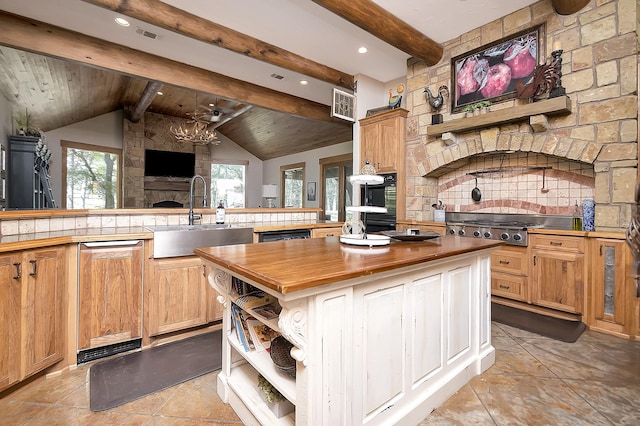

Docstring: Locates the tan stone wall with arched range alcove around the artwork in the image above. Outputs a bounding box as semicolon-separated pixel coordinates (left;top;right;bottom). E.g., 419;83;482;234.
406;0;638;231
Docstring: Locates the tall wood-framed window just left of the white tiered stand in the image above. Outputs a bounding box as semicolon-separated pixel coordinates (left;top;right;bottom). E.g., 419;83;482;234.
320;154;353;222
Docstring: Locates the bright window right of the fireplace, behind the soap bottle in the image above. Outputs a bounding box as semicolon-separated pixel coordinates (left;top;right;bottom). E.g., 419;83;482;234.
211;161;249;209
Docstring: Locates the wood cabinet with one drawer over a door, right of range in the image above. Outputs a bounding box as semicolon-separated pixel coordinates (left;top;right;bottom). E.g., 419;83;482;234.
530;235;585;314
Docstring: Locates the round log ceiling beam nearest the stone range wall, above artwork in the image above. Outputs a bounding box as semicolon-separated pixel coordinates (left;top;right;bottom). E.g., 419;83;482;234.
312;0;444;66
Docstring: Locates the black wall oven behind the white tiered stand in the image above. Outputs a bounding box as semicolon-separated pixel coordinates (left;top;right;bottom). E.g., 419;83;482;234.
360;173;396;232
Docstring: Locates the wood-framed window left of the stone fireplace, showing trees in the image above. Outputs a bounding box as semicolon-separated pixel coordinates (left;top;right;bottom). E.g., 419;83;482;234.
60;141;122;209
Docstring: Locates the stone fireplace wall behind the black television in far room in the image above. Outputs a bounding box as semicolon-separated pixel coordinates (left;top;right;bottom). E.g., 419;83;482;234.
122;112;211;208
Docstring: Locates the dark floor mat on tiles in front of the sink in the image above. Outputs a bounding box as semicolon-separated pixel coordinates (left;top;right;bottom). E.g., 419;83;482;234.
89;330;222;411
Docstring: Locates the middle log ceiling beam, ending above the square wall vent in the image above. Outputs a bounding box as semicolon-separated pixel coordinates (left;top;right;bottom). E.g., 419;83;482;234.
84;0;353;90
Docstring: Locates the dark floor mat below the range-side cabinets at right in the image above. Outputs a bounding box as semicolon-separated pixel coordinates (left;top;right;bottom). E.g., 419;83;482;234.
491;303;586;343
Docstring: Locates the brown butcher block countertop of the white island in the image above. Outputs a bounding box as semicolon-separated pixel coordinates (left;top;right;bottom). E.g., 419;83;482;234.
195;236;503;294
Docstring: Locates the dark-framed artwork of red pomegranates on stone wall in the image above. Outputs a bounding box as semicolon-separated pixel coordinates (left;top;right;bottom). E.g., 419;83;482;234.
451;24;545;112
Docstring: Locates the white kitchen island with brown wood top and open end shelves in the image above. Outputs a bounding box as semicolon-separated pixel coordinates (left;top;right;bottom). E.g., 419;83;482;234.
195;236;501;425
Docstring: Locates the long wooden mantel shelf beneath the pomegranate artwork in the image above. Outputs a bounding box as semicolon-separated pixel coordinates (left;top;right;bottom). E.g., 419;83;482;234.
427;96;571;136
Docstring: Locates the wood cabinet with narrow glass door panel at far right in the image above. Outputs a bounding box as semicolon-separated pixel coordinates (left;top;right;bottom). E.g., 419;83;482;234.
589;238;637;335
